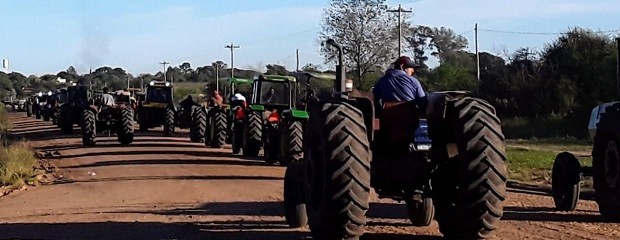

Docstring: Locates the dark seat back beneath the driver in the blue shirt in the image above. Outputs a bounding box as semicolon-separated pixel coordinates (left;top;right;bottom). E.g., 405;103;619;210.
379;102;420;146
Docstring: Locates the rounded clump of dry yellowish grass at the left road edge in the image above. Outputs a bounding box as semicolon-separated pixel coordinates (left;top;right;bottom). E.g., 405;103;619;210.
0;142;37;187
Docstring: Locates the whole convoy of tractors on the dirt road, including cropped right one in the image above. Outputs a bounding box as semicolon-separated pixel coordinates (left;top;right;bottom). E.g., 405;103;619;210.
23;40;620;239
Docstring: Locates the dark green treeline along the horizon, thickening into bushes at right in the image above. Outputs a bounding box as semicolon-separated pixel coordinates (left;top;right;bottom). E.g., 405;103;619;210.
0;26;617;138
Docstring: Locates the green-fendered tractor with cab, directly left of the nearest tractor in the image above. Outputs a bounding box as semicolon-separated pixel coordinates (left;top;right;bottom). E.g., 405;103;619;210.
243;75;308;165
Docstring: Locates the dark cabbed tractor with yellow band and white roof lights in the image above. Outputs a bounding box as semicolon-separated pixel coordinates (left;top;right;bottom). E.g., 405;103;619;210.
137;81;176;136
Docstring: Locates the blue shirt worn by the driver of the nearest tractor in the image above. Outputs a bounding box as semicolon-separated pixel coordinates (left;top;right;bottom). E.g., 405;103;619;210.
373;69;426;102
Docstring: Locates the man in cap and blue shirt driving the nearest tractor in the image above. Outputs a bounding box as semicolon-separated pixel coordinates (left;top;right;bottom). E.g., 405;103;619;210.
373;56;428;113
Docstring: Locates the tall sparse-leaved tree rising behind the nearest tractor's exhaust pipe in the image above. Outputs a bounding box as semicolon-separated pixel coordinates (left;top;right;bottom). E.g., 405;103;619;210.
319;0;398;86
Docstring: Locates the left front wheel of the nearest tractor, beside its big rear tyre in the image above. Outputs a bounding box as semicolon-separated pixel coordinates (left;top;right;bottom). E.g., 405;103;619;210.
284;160;308;228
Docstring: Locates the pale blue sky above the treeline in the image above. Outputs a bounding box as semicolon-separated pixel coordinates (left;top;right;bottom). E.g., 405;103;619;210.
0;0;620;75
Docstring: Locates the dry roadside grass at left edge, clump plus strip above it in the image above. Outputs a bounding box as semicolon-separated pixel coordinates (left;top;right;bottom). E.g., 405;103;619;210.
0;104;39;192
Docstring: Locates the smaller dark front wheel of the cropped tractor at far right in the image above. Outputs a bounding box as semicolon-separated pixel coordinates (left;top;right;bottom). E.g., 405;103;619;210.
551;152;581;211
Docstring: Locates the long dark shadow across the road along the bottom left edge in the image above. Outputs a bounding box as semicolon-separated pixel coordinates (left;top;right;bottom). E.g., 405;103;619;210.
0;221;308;240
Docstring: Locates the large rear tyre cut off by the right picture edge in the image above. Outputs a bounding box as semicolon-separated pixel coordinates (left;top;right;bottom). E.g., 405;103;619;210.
592;104;620;222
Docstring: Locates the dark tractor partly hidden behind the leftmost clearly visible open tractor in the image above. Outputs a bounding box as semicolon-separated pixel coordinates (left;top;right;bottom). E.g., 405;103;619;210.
58;85;92;134
